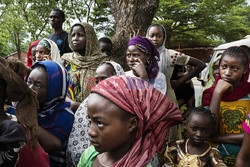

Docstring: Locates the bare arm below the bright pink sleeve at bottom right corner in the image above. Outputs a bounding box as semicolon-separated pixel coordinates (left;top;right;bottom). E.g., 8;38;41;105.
235;133;250;167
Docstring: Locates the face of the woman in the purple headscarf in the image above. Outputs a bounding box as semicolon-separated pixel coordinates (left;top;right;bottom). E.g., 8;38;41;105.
126;45;150;69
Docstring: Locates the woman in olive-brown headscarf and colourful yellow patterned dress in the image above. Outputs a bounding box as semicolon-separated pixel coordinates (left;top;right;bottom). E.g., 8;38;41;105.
62;23;107;106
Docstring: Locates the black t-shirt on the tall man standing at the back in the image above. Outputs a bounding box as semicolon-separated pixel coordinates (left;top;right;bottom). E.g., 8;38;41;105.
48;31;72;56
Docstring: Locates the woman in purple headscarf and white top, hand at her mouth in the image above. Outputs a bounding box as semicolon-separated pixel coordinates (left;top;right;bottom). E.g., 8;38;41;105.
125;36;167;95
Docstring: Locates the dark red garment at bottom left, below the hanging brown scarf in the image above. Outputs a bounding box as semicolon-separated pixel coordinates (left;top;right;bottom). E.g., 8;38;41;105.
17;143;50;167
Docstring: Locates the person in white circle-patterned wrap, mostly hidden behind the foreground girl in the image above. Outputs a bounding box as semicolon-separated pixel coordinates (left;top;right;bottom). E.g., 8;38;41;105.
67;61;124;167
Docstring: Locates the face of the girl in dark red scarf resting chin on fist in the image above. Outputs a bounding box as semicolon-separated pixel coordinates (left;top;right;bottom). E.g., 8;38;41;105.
220;55;246;87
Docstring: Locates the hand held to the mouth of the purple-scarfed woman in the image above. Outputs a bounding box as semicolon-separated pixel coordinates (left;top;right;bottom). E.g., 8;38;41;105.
132;59;148;79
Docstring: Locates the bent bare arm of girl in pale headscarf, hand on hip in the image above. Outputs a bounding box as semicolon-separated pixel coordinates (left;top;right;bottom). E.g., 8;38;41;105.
171;57;206;89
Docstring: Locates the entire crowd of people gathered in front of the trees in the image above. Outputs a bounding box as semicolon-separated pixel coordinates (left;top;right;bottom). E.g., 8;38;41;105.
0;9;250;167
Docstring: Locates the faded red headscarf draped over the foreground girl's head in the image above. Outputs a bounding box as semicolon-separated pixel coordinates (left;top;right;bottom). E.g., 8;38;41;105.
92;76;183;167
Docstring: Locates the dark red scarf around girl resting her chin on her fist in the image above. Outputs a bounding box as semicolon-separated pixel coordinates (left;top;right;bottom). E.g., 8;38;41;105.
202;56;250;106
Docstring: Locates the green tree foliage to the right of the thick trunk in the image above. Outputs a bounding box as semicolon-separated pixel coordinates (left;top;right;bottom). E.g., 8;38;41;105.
154;0;250;48
